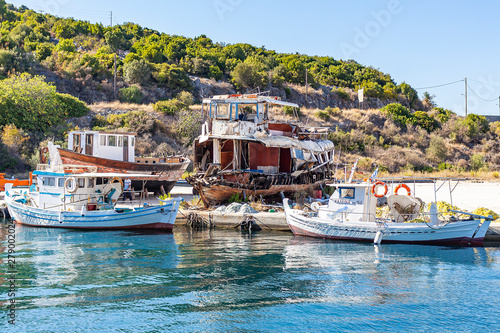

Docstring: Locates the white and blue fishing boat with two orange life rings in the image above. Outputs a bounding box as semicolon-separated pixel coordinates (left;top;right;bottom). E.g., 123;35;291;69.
283;180;492;246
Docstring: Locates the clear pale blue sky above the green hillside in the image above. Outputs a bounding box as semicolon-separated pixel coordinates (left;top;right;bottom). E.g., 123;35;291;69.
6;0;500;116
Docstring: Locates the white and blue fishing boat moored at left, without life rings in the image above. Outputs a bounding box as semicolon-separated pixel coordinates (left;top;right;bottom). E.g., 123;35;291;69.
5;165;182;230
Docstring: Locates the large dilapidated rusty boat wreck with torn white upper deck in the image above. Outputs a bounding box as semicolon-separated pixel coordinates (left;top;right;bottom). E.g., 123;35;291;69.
186;94;334;206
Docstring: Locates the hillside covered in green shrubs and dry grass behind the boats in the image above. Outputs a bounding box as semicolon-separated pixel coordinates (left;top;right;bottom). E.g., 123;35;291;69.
0;0;500;177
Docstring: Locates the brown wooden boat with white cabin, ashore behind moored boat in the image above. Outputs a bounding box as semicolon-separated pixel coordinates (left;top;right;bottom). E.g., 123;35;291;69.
58;131;190;193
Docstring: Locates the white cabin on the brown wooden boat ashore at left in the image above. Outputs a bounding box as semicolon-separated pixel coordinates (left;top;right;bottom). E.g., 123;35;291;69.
68;131;136;162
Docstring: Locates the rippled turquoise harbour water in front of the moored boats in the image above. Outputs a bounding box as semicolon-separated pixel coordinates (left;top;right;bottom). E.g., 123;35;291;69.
0;219;500;332
